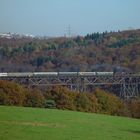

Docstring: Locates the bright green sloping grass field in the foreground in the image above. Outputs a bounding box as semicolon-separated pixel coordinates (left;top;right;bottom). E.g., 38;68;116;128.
0;106;140;140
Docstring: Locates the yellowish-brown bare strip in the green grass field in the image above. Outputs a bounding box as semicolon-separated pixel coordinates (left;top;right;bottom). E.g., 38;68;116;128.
0;121;65;128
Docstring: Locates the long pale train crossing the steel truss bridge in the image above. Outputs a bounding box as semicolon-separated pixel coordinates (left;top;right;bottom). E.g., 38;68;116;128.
0;72;131;77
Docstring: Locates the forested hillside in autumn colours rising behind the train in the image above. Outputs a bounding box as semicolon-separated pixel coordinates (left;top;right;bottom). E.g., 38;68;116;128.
0;30;140;72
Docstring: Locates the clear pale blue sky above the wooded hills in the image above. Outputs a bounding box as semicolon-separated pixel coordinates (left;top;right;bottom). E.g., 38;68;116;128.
0;0;140;36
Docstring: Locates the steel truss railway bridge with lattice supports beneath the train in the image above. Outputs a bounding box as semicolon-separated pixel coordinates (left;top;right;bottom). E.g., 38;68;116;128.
0;75;140;99
